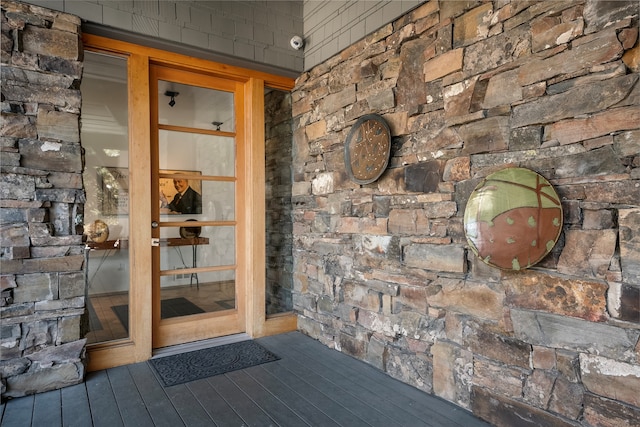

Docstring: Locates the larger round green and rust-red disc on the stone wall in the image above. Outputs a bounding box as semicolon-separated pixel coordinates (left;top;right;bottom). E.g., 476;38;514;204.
464;168;562;270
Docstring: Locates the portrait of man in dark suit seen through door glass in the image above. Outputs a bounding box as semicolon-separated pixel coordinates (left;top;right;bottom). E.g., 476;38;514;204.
159;169;202;215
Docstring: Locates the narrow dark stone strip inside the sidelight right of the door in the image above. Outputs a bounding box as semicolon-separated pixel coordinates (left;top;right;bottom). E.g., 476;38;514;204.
264;90;293;315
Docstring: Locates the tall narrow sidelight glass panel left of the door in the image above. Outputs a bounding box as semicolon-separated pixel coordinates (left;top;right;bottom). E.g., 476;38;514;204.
80;52;130;344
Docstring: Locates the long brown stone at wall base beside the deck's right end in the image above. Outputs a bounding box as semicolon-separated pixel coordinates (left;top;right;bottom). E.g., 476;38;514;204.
471;386;575;427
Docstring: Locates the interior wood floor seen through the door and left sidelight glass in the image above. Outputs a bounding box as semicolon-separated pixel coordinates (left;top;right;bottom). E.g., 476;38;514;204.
86;280;235;344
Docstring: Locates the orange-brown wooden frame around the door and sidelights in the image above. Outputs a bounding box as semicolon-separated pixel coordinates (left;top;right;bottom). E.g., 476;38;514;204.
83;34;297;371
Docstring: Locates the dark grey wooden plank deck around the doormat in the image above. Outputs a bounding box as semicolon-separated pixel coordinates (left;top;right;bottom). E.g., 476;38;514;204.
0;332;489;427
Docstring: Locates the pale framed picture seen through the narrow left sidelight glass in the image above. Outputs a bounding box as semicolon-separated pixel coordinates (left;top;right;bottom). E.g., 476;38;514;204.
97;166;129;215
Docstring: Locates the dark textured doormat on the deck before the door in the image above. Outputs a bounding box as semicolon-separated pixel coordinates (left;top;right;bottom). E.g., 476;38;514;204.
149;340;280;387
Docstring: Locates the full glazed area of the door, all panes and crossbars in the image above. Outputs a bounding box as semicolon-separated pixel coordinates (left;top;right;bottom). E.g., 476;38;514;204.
158;80;236;319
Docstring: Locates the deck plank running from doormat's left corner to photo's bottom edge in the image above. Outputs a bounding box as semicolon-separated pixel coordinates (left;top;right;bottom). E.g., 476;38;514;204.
128;362;182;427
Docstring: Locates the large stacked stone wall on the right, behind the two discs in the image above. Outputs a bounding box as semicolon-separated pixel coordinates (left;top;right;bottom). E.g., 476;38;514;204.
293;0;640;426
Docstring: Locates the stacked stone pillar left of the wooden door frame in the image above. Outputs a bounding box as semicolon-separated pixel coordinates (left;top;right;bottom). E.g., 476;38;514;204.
0;0;85;399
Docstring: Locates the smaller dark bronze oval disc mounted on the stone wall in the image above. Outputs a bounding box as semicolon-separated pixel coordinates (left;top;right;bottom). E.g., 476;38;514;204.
344;114;391;184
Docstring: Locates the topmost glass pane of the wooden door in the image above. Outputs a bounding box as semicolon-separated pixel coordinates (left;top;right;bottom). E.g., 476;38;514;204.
158;80;235;132
